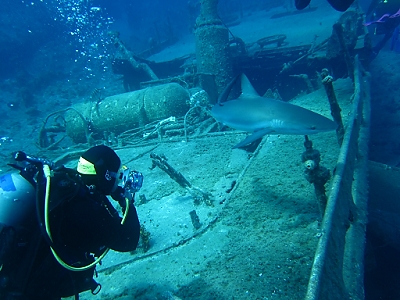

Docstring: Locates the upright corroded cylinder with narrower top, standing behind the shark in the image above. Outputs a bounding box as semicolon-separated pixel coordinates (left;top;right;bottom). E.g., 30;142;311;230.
195;0;232;102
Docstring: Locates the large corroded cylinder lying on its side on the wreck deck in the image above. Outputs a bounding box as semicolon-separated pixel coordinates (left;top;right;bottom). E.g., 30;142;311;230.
65;83;189;143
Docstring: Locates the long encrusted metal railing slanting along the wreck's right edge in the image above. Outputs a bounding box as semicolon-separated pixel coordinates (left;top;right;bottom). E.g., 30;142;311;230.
305;57;370;300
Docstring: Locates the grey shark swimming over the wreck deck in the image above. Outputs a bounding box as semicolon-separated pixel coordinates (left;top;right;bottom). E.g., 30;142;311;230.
211;74;337;148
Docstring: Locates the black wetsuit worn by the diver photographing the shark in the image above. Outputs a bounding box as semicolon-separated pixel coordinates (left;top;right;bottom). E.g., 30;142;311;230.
0;170;140;300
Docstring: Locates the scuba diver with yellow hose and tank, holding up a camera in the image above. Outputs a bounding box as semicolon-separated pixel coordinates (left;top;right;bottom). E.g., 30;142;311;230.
0;145;143;300
